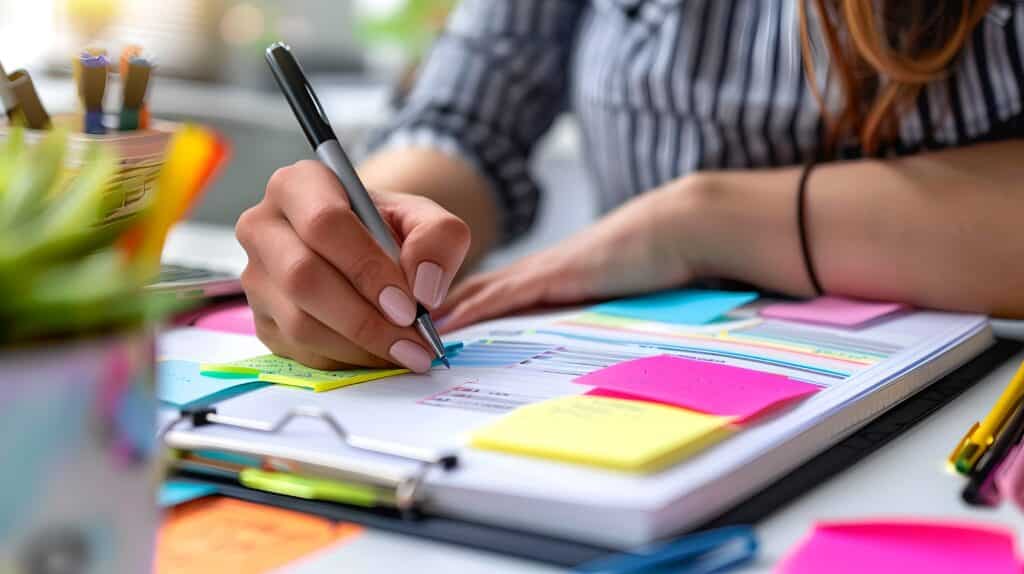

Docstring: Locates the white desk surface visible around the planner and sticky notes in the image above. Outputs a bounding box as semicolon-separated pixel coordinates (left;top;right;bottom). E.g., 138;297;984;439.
165;225;1024;574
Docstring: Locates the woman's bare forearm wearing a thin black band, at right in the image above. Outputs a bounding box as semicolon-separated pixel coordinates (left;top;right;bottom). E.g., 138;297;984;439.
678;141;1024;316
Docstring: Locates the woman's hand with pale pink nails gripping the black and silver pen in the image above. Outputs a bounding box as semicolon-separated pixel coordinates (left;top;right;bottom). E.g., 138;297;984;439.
236;161;470;372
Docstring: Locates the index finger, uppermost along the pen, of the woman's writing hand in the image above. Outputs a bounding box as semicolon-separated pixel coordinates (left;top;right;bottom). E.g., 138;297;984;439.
267;161;416;326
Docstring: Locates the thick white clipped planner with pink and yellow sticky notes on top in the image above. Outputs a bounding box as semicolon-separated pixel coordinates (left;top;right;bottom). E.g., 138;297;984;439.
159;296;994;548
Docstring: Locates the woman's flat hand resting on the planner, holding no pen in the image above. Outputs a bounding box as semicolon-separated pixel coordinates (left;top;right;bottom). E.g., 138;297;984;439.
434;178;702;333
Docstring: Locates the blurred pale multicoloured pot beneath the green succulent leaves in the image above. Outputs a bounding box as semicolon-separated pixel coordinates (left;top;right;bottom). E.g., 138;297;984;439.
0;328;160;574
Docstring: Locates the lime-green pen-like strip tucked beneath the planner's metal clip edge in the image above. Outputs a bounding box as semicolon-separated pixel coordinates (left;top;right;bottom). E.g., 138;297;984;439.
239;469;385;509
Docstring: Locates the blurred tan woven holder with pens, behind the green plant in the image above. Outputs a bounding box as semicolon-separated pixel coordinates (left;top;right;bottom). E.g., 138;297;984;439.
0;114;179;223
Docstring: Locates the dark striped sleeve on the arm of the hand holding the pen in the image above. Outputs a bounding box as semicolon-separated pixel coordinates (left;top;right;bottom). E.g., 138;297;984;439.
371;0;586;240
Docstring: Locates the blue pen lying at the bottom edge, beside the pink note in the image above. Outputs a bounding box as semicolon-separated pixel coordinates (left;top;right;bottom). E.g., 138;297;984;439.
573;526;758;574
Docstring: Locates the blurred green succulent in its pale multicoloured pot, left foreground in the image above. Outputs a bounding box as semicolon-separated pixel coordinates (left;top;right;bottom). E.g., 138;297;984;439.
0;129;177;573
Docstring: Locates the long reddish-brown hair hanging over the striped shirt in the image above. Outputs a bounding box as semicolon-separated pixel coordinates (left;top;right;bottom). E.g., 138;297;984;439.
800;0;994;156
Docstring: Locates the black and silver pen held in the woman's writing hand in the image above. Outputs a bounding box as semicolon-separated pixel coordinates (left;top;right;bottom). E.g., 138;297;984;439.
266;42;451;366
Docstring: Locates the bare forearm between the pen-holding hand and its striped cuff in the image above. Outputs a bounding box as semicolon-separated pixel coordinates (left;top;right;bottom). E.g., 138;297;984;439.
359;147;500;267
